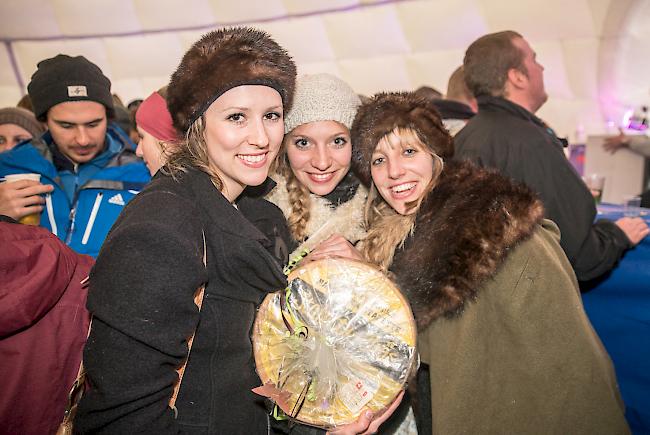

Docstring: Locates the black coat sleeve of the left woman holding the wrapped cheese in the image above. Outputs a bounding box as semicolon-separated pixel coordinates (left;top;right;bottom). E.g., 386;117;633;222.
75;195;206;435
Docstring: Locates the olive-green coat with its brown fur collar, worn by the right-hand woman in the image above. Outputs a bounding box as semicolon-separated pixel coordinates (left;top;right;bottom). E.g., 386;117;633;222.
384;163;630;435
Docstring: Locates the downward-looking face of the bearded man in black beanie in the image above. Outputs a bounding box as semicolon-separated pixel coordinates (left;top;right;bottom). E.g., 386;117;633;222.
47;101;108;164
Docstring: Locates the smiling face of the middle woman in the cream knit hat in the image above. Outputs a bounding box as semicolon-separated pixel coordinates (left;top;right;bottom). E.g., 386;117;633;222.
285;121;352;196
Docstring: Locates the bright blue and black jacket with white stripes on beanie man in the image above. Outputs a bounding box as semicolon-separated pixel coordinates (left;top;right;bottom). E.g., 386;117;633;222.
0;127;150;257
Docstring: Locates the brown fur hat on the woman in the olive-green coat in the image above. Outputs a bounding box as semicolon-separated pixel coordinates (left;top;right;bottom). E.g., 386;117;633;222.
351;92;454;186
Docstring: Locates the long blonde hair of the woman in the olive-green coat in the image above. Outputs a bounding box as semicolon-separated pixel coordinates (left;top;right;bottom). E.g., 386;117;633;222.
359;127;444;270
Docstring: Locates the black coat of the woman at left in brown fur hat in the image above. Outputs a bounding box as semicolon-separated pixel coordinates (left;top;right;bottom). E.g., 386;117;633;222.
75;171;288;435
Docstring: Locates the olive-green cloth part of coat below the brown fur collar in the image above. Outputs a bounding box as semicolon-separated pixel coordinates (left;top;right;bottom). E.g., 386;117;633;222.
418;221;629;435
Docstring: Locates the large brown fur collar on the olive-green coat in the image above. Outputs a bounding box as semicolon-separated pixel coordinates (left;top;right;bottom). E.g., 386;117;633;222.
390;162;544;329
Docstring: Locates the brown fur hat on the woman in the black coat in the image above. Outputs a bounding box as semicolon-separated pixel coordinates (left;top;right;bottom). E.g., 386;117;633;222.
167;27;296;133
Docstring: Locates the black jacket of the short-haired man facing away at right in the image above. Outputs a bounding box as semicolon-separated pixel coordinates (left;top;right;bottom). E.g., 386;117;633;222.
454;96;630;281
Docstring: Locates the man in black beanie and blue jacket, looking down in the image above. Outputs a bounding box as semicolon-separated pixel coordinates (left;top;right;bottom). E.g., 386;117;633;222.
0;54;149;256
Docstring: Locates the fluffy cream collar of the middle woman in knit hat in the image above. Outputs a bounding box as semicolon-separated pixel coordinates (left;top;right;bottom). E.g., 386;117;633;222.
266;174;368;249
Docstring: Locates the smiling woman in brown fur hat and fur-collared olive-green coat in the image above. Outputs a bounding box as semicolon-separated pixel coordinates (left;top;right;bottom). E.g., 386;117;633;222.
352;93;629;435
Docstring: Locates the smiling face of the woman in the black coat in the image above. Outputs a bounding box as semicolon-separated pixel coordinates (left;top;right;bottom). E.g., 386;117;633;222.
204;85;284;202
